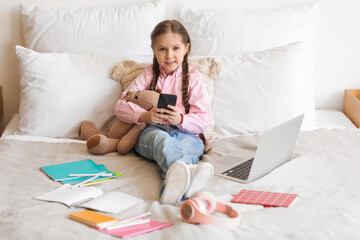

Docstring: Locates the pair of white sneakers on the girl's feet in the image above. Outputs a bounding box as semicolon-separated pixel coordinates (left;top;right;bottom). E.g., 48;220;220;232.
160;161;214;204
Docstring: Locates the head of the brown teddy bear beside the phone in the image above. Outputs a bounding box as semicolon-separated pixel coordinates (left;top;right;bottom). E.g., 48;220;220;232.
126;90;161;111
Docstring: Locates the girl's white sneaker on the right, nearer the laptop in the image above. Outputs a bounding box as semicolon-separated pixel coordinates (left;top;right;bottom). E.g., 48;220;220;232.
185;162;214;198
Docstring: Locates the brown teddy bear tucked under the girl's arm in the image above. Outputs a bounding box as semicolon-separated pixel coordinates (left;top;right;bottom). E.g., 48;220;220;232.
79;90;161;154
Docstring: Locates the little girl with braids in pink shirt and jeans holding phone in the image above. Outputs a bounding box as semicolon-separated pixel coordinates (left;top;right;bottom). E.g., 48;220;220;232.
115;20;214;204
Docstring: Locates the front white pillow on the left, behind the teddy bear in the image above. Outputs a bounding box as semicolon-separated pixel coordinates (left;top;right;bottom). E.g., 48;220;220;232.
16;46;151;138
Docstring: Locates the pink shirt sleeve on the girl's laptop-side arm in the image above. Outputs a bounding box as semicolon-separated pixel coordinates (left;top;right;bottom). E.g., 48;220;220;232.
178;70;210;134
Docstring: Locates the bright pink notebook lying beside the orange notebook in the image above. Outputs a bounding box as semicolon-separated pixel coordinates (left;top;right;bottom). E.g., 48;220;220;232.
98;219;173;238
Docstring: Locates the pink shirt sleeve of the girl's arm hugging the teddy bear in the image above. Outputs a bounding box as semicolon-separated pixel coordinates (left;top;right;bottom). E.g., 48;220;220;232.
115;68;152;124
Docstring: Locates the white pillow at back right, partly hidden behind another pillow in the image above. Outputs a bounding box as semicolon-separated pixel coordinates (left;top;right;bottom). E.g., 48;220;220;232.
180;3;318;56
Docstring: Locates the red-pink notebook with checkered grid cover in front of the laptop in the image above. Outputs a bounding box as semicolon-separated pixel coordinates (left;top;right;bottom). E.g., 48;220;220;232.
231;190;298;207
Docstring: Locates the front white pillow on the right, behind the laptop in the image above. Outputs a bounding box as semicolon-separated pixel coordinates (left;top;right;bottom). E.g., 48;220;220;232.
212;42;315;137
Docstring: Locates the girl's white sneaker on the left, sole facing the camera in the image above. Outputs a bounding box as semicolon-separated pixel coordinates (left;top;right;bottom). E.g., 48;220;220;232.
160;161;190;204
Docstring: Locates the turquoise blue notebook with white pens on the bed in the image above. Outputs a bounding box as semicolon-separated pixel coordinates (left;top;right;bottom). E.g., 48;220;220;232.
40;159;116;184
